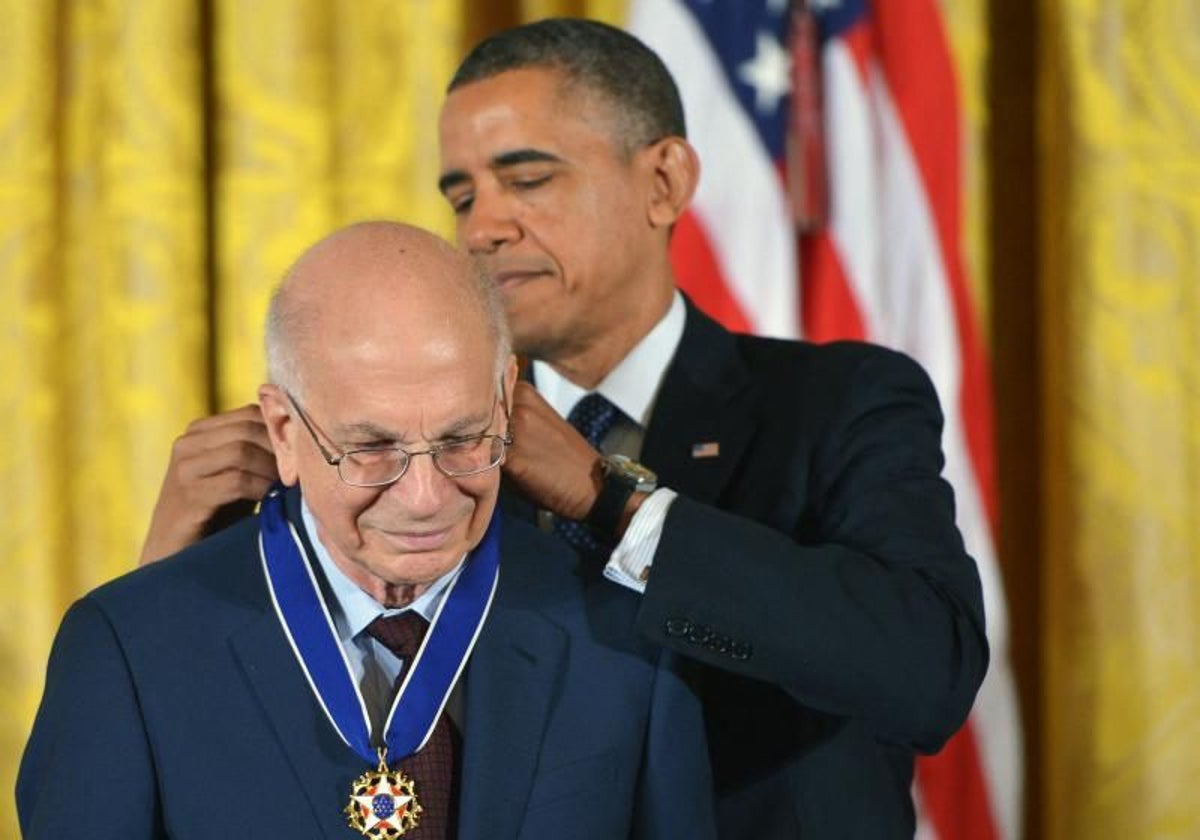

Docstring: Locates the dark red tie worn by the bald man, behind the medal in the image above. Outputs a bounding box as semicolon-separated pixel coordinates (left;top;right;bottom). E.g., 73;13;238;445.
367;611;462;840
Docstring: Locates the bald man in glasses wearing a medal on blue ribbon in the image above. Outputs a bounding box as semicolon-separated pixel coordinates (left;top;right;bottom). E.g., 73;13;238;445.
17;222;714;840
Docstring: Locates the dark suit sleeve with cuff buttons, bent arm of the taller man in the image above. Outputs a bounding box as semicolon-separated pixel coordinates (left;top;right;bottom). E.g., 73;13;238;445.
637;350;988;751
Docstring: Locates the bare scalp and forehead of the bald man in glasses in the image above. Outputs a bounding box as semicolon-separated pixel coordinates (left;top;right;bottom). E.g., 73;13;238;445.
266;221;509;397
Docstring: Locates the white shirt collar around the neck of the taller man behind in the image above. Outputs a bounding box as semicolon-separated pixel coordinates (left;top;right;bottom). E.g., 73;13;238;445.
533;292;688;428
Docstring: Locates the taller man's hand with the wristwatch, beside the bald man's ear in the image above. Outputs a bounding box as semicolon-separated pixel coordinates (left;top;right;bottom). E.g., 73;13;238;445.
504;382;601;520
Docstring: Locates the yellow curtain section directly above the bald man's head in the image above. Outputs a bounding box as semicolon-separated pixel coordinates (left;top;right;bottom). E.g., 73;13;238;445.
212;0;463;408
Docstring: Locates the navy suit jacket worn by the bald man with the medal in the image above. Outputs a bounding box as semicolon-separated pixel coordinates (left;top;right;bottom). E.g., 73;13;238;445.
17;498;713;840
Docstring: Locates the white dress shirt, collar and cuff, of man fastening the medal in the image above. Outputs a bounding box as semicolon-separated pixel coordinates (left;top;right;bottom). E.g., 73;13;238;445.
533;292;688;592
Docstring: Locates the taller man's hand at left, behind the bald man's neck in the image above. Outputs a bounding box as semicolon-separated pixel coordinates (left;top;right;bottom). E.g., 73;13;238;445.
139;403;280;565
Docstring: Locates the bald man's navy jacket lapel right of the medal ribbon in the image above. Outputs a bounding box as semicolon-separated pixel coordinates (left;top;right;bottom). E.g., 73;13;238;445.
458;583;568;840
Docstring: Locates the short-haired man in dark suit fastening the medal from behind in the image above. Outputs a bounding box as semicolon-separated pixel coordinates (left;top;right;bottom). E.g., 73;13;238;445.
136;20;988;840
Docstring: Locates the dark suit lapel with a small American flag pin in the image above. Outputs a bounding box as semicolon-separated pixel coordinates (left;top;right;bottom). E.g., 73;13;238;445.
641;301;760;504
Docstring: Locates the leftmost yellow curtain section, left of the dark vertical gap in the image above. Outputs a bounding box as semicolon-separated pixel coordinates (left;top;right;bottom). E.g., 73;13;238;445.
0;0;206;836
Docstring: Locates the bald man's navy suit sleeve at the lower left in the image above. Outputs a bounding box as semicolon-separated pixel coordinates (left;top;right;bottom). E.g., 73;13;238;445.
17;599;166;840
